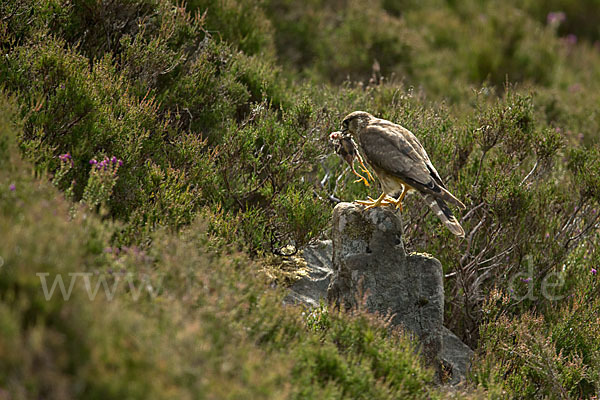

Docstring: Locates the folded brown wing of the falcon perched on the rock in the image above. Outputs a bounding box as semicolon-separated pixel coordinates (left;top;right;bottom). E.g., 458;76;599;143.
359;120;464;208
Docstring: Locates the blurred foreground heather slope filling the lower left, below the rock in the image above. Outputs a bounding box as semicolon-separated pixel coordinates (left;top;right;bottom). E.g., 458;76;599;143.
0;97;438;399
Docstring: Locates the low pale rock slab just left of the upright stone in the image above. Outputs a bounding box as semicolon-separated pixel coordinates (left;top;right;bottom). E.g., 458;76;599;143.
284;240;332;307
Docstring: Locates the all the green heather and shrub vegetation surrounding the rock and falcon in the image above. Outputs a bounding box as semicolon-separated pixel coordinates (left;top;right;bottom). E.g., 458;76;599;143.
0;0;600;399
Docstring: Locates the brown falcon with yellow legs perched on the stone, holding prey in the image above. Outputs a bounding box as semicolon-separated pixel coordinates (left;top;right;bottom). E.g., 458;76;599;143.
340;111;465;237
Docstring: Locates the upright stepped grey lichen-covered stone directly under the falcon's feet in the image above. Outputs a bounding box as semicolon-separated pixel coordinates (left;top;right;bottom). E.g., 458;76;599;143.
328;203;444;362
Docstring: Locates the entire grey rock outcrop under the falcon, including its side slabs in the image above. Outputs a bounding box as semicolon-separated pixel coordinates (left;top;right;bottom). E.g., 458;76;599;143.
286;203;473;384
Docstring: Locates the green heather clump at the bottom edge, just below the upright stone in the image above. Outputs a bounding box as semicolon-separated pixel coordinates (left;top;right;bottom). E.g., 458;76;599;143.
295;306;432;399
